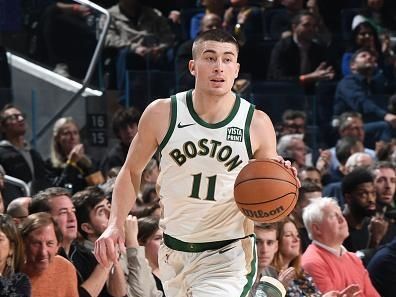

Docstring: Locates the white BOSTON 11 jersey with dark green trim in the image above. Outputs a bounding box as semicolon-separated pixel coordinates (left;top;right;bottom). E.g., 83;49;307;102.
158;90;254;243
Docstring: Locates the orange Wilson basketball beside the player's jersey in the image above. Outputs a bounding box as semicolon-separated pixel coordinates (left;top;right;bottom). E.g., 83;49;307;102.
234;159;298;223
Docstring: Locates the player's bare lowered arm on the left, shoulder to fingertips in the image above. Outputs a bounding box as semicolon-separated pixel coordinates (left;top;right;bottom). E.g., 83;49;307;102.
95;99;170;266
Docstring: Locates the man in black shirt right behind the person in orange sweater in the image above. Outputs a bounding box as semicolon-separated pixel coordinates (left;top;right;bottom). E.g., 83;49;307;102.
29;188;115;296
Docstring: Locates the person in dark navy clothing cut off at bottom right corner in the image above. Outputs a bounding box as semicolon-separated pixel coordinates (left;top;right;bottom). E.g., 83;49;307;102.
367;237;396;297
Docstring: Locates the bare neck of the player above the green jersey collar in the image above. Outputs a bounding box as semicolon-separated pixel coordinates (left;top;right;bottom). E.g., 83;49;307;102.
192;91;236;124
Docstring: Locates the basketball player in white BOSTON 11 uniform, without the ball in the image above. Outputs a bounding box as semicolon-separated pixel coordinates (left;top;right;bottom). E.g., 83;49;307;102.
95;29;296;297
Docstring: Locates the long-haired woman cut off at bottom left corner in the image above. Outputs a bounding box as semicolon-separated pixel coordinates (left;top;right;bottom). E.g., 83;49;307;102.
0;214;31;297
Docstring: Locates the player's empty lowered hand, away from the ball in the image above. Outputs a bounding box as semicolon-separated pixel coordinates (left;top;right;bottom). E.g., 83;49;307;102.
94;225;125;267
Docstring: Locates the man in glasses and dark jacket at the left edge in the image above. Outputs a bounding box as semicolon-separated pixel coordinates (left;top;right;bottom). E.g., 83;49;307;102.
0;104;49;204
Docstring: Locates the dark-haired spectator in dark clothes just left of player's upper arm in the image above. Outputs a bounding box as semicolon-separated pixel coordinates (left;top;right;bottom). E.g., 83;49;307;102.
100;107;141;176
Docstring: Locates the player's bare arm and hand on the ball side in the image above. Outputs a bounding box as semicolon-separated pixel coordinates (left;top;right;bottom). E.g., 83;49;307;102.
250;110;300;185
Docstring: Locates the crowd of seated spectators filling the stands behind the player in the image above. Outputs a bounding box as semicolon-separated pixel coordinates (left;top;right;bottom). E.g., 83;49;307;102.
0;0;396;297
